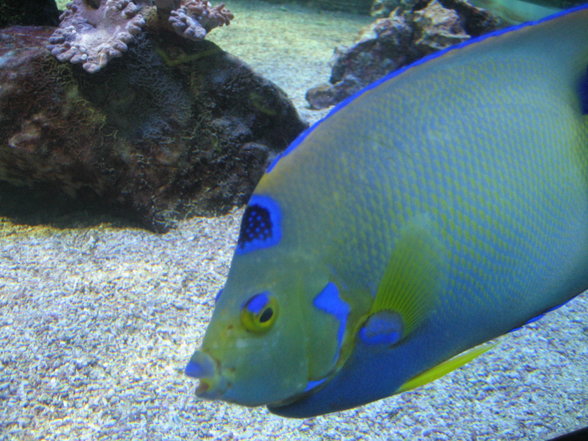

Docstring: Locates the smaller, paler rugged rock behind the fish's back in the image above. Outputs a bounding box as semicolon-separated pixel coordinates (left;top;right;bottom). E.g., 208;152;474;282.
306;0;499;109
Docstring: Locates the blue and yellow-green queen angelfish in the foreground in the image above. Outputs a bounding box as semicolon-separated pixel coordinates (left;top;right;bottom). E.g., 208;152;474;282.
186;6;588;417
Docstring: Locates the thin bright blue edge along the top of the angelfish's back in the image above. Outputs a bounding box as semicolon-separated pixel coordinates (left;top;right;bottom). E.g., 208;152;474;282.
265;4;588;173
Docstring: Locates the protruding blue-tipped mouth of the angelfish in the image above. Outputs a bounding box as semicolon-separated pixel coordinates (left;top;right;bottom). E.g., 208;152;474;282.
184;351;230;400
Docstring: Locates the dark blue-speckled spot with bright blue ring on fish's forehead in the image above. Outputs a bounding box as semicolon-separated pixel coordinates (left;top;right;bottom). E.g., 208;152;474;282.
236;195;282;254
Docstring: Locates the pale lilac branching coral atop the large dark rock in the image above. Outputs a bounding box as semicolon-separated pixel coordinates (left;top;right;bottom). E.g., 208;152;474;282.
48;0;233;73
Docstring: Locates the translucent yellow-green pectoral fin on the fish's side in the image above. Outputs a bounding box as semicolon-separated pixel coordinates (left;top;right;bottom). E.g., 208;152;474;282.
369;215;448;337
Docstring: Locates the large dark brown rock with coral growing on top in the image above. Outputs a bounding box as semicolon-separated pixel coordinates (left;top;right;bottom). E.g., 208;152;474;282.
0;27;305;231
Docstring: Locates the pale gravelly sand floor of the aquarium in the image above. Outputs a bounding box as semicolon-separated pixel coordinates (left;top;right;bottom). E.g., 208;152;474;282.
0;2;588;441
